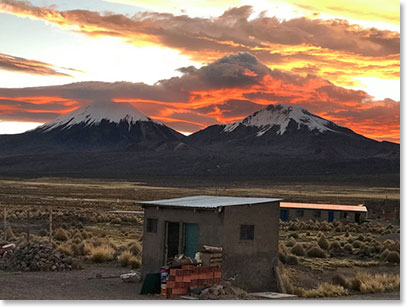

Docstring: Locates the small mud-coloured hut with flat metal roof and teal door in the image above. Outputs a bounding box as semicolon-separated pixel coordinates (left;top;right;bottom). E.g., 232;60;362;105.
139;196;280;291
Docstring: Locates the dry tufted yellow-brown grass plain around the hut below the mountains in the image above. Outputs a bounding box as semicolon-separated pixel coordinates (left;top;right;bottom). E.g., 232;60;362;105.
0;178;400;298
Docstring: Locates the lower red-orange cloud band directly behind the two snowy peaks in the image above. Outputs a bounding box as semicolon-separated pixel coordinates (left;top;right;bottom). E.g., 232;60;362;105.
0;53;400;141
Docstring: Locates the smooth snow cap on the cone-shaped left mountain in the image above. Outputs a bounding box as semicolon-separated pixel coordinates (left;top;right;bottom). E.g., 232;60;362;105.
39;100;162;131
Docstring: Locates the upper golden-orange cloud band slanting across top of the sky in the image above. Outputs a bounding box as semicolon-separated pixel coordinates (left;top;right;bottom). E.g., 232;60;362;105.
0;0;400;90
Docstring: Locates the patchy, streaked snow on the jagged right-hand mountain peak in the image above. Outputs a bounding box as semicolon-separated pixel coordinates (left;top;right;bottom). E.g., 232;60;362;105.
223;104;337;136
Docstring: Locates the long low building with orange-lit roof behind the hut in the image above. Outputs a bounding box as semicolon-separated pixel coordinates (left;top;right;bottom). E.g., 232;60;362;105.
280;202;367;223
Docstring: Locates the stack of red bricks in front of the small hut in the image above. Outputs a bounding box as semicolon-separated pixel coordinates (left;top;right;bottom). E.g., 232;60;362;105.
167;265;221;298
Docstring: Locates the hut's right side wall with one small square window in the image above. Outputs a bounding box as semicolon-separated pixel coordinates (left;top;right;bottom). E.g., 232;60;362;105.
222;202;280;291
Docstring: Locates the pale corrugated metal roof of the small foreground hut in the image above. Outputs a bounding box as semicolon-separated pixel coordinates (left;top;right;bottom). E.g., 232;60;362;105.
139;195;281;209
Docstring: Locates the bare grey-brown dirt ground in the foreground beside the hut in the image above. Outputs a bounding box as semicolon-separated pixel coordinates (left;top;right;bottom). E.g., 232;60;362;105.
0;264;400;300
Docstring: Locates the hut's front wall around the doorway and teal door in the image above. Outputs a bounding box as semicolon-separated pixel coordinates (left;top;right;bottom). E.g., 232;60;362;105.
142;206;224;275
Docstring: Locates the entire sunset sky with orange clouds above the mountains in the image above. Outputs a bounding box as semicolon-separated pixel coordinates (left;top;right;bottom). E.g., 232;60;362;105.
0;0;400;142
